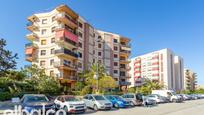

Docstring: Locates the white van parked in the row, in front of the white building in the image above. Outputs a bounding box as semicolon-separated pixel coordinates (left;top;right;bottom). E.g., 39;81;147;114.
152;90;183;102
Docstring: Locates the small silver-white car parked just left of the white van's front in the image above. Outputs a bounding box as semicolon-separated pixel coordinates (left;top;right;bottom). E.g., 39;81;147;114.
147;94;168;103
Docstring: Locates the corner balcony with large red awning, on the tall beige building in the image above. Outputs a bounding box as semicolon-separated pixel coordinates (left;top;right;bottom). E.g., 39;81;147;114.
55;27;78;43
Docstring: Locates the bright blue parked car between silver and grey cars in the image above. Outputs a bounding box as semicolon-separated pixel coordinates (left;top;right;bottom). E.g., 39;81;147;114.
104;95;130;108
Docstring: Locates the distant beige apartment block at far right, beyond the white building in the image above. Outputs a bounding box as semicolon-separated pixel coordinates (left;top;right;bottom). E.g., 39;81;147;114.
184;68;197;91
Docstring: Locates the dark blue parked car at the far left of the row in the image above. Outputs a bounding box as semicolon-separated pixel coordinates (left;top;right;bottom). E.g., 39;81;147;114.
20;94;55;113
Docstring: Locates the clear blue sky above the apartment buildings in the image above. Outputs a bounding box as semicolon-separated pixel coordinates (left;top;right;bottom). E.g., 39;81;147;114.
0;0;204;84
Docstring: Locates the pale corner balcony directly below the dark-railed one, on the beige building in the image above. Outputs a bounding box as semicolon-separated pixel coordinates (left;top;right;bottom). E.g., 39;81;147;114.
54;61;77;71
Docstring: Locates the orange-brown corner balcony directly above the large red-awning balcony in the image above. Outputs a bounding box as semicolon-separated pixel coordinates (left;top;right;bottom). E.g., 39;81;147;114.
56;13;77;29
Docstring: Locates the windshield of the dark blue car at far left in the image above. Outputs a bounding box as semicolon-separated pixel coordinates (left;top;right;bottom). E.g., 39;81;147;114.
24;96;48;102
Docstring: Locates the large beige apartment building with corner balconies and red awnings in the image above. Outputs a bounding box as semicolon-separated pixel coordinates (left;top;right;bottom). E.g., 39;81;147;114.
25;5;131;88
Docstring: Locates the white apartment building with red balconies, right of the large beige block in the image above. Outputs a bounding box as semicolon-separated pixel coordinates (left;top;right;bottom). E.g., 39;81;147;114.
129;49;183;91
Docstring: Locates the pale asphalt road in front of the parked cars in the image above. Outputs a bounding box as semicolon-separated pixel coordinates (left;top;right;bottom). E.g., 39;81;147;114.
85;99;204;115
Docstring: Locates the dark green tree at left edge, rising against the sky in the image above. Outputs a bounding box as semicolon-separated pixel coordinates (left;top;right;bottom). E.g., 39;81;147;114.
0;39;18;77
